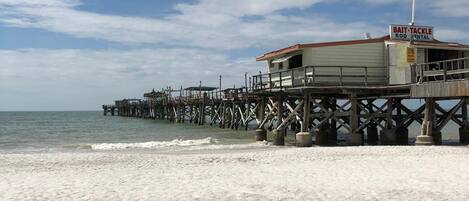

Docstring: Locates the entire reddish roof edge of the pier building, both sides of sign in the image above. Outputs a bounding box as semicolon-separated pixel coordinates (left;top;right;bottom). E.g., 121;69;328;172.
256;35;469;61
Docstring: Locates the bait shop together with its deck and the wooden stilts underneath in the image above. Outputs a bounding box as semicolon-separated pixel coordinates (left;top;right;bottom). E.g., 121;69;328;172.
251;25;469;145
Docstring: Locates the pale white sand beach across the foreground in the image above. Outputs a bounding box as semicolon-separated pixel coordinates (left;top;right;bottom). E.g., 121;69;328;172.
0;147;469;200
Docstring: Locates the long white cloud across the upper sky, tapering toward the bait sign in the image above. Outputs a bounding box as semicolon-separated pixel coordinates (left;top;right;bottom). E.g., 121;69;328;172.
0;0;383;50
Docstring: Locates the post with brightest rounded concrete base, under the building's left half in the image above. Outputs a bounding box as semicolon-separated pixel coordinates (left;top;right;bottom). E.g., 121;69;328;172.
295;92;313;147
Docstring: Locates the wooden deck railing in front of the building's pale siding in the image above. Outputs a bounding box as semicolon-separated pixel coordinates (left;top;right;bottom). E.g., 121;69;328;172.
251;66;389;90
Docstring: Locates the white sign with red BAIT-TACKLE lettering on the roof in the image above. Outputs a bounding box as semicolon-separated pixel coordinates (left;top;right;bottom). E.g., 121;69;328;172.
389;24;433;41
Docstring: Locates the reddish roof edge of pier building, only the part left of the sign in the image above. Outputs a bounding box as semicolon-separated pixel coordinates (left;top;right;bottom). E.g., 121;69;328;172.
256;35;390;61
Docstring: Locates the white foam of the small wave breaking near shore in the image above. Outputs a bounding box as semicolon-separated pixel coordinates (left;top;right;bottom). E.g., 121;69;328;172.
90;137;218;150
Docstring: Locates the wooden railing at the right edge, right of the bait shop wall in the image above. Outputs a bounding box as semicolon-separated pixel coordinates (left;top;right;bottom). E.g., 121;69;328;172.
412;57;469;83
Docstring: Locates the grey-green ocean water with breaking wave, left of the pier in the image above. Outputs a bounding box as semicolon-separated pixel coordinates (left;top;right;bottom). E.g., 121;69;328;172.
0;112;253;152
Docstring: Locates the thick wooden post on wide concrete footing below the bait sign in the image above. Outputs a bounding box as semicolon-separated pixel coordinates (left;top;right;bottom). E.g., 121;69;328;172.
415;98;441;145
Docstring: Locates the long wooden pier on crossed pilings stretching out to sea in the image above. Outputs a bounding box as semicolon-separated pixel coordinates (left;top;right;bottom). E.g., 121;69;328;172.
103;58;469;146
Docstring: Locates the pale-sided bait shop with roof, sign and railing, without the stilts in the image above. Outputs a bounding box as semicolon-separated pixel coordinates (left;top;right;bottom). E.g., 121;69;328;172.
254;25;469;88
